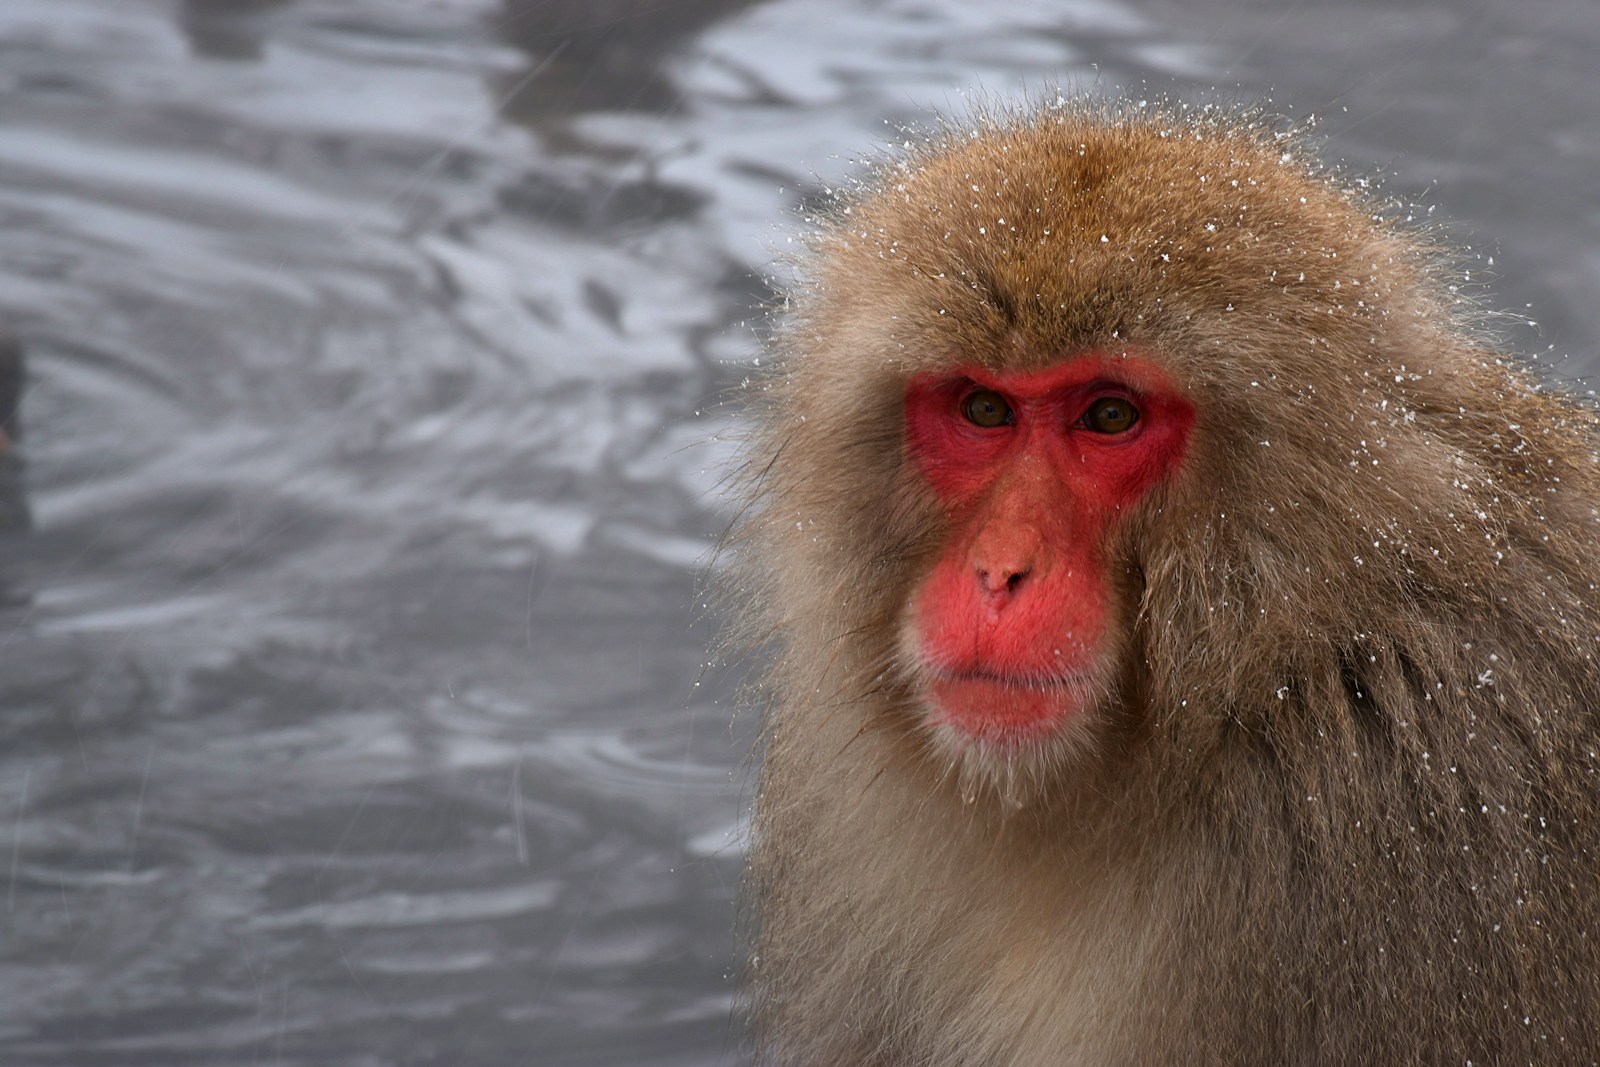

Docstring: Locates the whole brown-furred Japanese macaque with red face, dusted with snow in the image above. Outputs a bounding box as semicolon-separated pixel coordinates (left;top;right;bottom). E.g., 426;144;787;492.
738;97;1600;1067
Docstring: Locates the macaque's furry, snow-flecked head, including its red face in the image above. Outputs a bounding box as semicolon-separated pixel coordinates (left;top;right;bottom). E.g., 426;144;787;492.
754;106;1589;799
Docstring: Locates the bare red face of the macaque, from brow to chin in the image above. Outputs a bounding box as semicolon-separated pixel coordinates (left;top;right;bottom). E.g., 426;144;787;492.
906;354;1194;745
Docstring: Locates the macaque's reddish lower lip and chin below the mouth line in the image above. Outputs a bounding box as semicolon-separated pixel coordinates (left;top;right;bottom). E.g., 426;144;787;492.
928;669;1090;742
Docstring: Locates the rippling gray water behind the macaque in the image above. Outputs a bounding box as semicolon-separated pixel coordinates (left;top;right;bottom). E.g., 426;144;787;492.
0;0;1600;1065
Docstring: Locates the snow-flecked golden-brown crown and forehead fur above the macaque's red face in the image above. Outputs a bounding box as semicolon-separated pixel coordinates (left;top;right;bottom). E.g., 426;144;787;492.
800;112;1442;379
